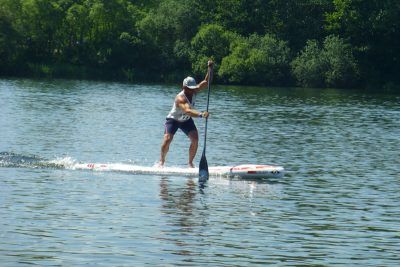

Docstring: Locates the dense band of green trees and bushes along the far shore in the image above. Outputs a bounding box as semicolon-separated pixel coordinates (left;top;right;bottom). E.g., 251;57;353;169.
0;0;400;88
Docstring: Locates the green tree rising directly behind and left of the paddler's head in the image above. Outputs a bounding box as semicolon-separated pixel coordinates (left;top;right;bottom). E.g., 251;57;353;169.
138;0;199;73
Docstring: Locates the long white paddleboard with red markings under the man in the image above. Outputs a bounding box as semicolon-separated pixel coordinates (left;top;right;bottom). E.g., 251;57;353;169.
72;163;284;179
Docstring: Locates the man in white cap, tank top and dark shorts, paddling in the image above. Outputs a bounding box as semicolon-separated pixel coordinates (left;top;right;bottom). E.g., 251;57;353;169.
159;60;213;168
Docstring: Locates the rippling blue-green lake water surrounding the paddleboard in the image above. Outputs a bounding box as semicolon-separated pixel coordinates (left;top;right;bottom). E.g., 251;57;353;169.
0;79;400;266
